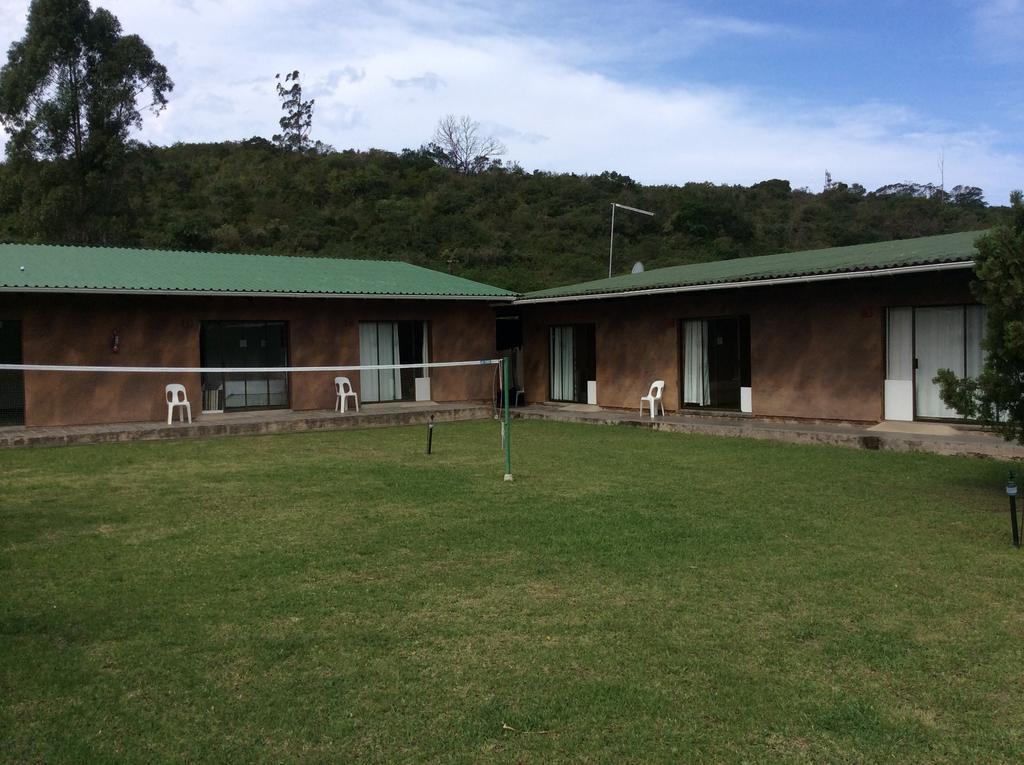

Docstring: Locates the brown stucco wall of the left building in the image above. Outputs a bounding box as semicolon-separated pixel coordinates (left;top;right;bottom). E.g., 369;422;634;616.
0;293;495;425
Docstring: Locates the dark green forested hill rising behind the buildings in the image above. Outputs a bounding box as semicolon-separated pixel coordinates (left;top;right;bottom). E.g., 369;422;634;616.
0;138;1006;290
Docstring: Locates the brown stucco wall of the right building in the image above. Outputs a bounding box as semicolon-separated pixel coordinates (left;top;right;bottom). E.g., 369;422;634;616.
519;271;974;421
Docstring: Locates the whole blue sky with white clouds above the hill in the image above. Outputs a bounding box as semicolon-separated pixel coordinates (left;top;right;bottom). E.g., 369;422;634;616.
0;0;1024;204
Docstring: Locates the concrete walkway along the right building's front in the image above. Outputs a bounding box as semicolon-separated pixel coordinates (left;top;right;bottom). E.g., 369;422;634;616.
513;403;1024;460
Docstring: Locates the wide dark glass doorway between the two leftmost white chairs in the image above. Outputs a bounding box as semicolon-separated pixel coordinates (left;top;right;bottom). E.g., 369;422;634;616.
200;322;288;412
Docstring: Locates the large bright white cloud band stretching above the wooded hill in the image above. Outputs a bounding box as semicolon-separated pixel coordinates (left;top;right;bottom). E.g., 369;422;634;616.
0;0;1024;203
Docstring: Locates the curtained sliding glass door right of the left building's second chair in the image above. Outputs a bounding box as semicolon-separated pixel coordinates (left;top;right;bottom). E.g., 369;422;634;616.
359;321;430;403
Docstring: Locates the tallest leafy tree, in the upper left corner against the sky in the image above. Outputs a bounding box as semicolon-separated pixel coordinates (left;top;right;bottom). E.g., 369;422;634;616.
0;0;174;242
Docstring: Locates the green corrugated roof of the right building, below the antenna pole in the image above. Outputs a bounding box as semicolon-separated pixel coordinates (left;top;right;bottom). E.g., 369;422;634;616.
522;231;984;300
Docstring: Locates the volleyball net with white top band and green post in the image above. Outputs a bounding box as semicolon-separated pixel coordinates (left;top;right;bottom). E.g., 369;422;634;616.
0;357;512;480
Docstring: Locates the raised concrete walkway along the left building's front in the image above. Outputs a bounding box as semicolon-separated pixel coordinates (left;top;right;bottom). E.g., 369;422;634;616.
0;401;494;449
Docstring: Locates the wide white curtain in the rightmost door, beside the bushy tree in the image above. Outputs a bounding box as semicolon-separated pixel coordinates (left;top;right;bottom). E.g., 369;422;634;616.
914;305;965;417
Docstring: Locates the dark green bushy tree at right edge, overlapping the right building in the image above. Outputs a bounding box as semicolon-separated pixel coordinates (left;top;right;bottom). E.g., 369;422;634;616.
935;190;1024;443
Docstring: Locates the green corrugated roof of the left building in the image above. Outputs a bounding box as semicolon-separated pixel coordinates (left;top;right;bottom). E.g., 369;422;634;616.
0;245;515;299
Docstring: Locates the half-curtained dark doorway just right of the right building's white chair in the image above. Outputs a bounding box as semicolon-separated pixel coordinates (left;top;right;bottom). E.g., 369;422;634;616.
681;316;751;410
